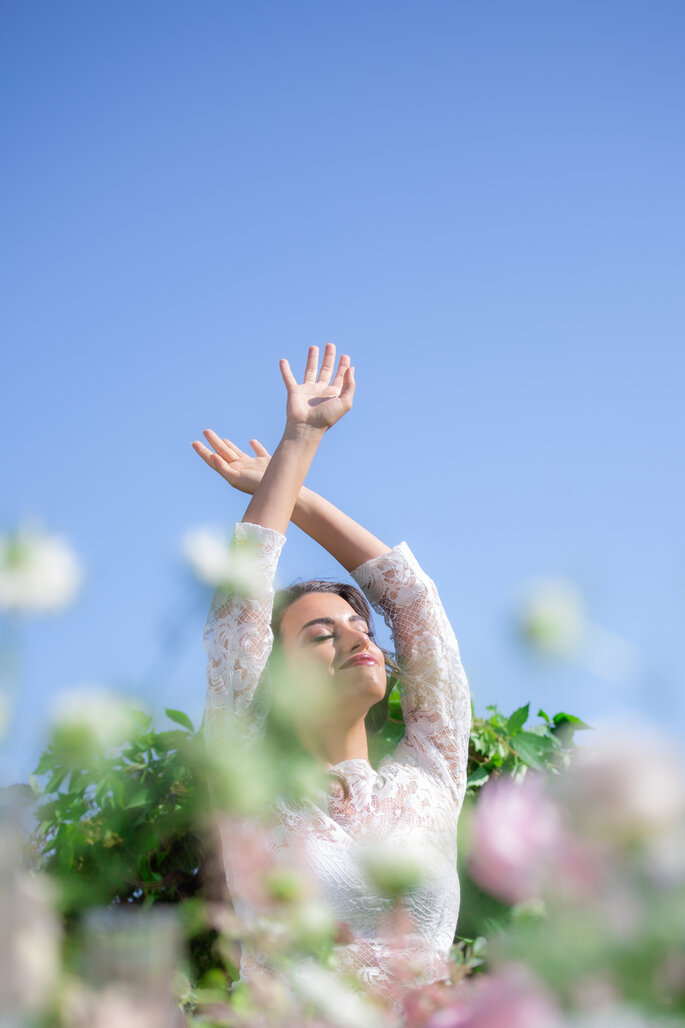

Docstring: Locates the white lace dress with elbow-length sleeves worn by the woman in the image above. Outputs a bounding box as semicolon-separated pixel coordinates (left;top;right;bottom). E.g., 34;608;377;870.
205;522;471;987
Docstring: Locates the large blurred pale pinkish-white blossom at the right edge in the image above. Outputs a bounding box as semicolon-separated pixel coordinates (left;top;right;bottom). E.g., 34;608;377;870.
560;729;685;842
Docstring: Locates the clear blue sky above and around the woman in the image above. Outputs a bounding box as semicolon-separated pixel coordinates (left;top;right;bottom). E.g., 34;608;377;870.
0;0;685;778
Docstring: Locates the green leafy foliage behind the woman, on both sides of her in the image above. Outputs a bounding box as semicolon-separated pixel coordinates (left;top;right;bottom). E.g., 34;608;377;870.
24;684;587;987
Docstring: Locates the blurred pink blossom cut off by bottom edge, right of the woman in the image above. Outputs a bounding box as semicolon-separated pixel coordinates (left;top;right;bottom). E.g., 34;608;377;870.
426;964;564;1028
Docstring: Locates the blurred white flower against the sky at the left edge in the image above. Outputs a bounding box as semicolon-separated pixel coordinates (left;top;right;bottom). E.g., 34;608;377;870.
0;525;83;614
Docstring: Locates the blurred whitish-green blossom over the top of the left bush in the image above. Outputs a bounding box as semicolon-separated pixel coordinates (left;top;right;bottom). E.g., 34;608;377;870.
52;686;146;756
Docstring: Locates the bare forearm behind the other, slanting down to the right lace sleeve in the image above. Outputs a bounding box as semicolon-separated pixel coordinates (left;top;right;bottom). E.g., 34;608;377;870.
290;487;390;572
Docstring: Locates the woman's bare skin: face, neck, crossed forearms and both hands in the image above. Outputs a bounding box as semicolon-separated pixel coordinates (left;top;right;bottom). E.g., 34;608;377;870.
192;343;389;766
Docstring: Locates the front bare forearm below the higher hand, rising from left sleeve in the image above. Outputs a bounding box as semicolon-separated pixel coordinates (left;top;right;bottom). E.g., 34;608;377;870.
243;425;323;535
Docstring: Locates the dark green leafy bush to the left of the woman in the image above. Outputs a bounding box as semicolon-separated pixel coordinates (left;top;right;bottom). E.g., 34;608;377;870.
34;711;203;913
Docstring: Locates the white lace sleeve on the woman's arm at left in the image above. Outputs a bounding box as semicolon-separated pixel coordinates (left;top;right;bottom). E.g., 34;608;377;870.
205;521;285;743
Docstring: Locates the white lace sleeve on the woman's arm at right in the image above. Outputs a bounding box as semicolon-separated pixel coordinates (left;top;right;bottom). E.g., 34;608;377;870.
353;543;471;803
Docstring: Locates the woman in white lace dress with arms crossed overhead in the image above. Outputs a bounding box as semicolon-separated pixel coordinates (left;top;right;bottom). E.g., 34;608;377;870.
192;344;471;987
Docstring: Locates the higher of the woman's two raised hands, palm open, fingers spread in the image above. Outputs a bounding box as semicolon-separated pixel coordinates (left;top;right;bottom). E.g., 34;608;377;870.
281;342;355;432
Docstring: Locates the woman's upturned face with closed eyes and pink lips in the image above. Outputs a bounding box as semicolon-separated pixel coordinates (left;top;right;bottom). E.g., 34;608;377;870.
281;592;387;717
